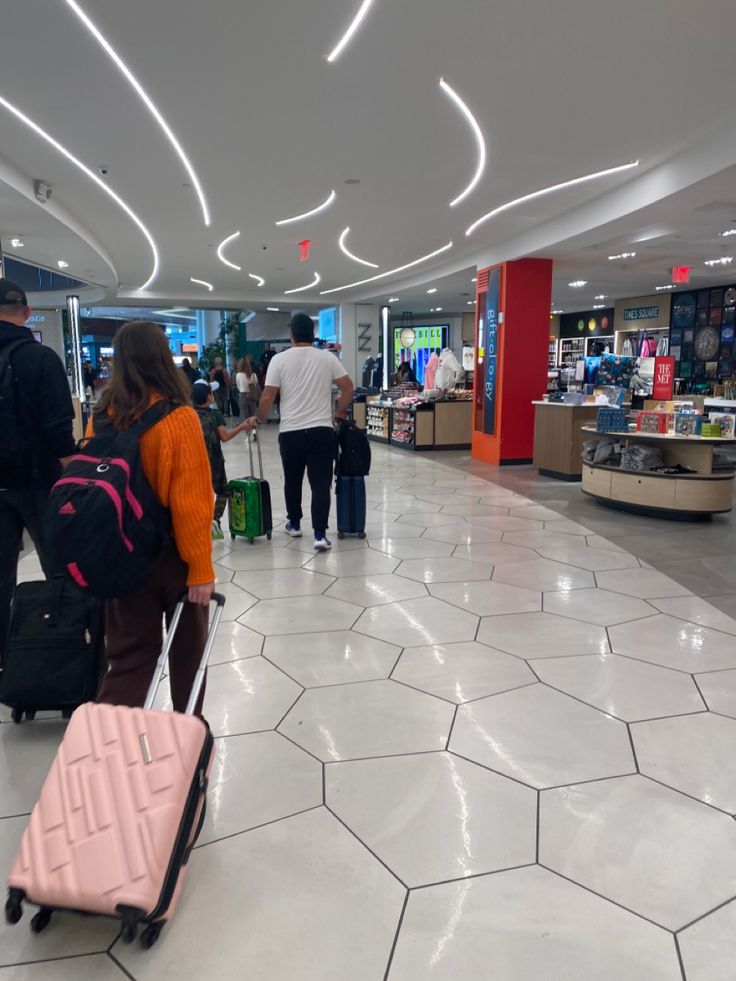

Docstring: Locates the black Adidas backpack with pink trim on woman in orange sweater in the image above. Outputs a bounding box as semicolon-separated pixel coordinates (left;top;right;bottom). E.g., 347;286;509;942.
46;401;175;598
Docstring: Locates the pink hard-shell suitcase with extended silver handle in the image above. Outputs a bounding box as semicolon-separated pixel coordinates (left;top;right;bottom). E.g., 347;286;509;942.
5;593;225;947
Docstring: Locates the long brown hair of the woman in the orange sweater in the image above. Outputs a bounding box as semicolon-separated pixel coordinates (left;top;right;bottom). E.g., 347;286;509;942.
97;320;192;429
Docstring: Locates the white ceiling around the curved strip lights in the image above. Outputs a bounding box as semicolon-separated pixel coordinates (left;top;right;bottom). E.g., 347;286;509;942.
0;0;736;312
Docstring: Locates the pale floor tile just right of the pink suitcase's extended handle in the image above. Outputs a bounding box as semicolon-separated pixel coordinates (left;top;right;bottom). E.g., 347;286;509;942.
156;657;301;736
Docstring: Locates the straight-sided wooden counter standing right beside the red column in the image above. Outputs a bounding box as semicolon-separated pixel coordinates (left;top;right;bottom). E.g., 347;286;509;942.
532;402;599;480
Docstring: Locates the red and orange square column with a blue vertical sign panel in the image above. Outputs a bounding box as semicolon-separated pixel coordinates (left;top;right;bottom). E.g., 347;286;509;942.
472;259;552;465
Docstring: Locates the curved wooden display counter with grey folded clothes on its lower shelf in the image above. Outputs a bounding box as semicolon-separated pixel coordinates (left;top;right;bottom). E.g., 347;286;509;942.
582;426;736;519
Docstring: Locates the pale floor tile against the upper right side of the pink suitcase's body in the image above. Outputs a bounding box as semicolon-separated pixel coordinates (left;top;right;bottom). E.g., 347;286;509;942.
198;732;322;847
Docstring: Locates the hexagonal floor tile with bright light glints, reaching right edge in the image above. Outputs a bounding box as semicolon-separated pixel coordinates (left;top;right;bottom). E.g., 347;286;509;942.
609;615;736;673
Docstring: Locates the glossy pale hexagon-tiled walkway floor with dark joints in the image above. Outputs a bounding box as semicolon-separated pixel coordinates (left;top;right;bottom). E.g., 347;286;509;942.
0;430;736;981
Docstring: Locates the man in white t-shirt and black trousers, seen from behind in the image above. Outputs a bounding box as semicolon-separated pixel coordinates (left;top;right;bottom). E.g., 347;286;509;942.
258;313;354;552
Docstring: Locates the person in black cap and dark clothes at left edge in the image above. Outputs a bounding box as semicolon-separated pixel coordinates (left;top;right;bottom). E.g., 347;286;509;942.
0;279;75;654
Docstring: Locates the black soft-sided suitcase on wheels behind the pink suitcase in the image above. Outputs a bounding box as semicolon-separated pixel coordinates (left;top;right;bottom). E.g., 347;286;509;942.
0;578;105;722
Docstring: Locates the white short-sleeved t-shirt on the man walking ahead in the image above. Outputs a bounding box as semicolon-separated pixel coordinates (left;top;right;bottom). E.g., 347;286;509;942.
266;347;347;433
